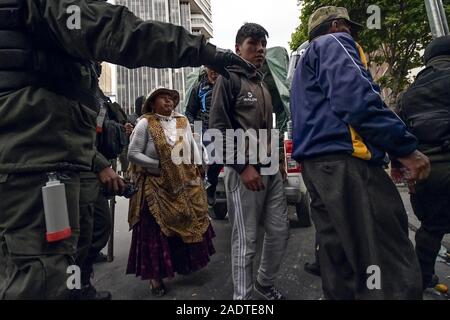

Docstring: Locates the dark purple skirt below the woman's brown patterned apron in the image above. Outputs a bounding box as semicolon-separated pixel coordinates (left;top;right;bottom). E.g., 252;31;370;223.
126;201;215;280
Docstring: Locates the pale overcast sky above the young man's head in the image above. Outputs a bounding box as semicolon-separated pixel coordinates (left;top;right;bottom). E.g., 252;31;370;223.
211;0;300;52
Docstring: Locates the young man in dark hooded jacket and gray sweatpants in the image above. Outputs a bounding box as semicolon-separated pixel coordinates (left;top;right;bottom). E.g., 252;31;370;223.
209;23;289;300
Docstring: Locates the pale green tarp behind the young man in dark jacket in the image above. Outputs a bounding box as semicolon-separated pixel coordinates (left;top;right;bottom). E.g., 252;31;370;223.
181;47;290;136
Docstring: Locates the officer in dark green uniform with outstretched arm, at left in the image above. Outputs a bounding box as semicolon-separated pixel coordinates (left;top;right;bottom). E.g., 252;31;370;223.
0;0;251;299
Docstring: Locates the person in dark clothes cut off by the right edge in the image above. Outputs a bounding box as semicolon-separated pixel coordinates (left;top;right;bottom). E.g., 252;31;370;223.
399;36;450;289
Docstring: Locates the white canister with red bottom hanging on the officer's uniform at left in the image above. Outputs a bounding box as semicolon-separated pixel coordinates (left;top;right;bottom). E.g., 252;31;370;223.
42;172;72;242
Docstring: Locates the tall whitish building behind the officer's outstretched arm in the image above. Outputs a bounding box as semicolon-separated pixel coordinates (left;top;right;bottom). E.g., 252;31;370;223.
115;0;213;113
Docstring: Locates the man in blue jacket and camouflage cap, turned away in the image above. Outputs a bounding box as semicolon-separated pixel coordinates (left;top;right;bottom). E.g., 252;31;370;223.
291;7;430;299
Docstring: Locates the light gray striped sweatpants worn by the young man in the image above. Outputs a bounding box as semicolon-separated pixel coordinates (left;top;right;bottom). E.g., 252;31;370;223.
225;167;289;300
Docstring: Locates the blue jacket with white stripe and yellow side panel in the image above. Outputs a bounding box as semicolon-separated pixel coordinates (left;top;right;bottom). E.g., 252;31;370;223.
290;33;417;165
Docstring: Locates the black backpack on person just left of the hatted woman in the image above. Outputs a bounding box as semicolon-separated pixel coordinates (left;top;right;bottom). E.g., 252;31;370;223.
97;100;128;160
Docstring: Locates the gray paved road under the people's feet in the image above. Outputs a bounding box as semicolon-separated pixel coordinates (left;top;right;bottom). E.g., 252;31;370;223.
94;190;450;300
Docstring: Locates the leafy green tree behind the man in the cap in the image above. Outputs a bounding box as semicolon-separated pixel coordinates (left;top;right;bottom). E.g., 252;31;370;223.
289;0;450;106
